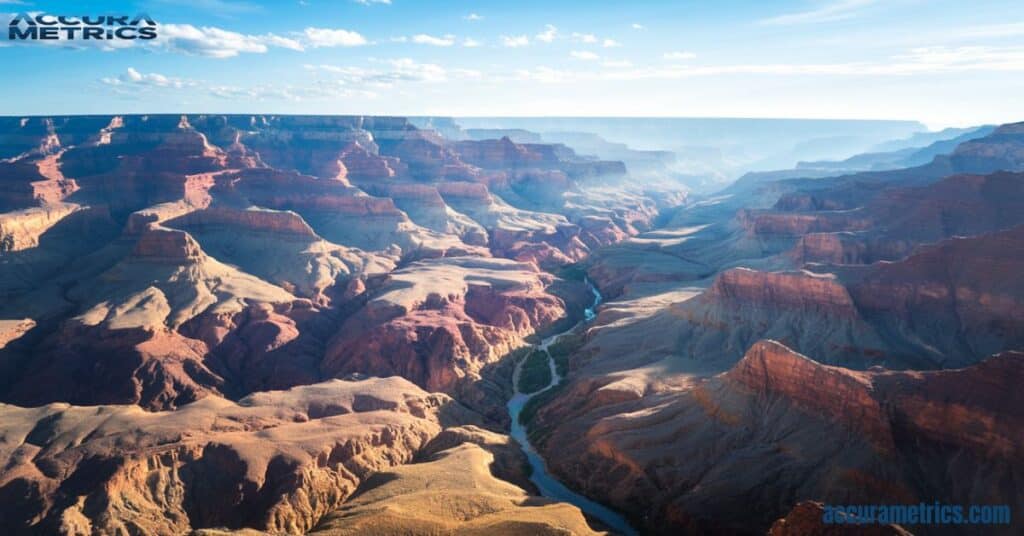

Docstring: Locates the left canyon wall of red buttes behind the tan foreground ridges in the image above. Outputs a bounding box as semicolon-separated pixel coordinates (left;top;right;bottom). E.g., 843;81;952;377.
0;115;654;424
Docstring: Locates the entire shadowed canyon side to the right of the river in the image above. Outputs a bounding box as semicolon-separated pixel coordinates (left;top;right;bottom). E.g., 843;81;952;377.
530;119;1024;534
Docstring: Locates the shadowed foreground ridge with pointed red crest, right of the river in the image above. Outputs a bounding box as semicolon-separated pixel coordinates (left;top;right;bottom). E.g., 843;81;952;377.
531;341;1024;534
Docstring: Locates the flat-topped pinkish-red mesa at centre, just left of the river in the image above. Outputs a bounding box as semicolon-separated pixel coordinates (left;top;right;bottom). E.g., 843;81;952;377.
323;257;566;393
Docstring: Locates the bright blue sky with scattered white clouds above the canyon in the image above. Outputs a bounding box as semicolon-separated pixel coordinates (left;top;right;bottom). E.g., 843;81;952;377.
0;0;1024;128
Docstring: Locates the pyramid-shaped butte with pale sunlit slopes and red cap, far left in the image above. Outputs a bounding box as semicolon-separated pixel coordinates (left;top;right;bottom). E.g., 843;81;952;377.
8;226;301;408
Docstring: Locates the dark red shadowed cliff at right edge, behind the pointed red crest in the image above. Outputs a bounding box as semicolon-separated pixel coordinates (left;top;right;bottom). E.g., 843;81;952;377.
848;225;1024;367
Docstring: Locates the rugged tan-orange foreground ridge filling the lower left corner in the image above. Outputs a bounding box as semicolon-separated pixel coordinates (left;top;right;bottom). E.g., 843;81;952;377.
0;378;474;534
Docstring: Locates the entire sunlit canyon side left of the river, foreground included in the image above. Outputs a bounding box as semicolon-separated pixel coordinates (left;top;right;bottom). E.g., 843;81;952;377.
0;115;685;534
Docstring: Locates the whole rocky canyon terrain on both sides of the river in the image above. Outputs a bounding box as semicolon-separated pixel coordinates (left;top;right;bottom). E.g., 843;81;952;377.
0;115;1024;535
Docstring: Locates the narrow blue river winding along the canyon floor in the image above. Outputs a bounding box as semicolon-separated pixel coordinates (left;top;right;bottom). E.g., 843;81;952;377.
508;280;637;535
